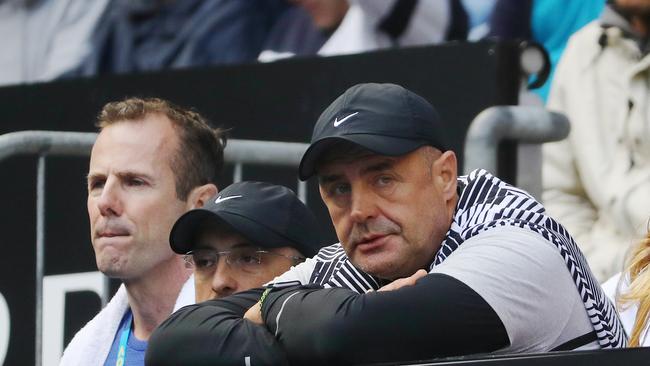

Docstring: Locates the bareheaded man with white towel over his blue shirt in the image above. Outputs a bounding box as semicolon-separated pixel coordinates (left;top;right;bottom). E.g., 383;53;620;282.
61;98;226;365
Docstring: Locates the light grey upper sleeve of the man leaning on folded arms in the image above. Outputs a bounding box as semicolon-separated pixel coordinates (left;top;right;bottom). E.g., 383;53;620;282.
432;226;593;353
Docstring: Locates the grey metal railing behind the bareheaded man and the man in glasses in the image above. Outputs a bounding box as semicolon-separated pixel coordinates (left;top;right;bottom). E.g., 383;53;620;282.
0;131;308;366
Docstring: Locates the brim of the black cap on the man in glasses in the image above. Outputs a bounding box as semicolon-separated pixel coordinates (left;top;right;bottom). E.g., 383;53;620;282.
169;209;316;256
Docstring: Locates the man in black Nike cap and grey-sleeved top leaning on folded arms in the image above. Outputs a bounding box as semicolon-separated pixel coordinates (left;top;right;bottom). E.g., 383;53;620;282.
147;84;626;365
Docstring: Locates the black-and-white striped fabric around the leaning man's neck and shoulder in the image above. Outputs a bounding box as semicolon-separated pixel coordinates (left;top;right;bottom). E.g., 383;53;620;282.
274;170;627;348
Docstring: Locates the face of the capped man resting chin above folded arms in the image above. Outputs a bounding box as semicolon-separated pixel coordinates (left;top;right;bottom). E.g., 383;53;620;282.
318;147;456;279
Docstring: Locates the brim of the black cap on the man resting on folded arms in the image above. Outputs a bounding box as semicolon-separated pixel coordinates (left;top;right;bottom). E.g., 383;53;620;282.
298;134;431;180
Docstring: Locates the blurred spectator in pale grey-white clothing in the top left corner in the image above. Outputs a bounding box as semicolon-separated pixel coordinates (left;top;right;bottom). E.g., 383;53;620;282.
0;0;109;85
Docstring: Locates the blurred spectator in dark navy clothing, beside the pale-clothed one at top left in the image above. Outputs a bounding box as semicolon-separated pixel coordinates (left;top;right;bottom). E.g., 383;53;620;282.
73;0;288;75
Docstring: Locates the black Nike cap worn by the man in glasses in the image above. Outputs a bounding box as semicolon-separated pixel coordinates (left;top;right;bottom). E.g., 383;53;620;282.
169;181;322;257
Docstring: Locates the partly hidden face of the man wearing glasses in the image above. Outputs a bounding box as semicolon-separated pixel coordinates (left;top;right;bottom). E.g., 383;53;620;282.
193;229;300;302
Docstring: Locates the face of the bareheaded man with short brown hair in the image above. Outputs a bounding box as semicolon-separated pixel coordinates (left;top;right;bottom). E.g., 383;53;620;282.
88;115;188;281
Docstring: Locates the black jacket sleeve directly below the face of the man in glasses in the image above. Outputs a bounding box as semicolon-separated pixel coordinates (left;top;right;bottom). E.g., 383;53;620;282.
145;289;288;366
